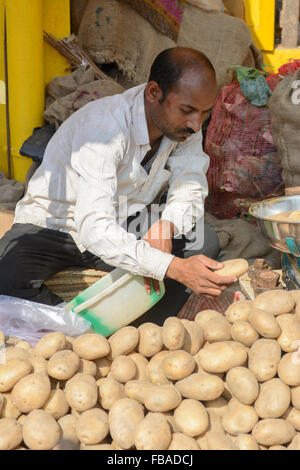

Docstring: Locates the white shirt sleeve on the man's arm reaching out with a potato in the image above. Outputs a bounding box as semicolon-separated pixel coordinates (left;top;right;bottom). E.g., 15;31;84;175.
73;141;174;280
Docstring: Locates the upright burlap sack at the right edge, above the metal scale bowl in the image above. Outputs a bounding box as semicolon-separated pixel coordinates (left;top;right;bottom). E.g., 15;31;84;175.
268;70;300;188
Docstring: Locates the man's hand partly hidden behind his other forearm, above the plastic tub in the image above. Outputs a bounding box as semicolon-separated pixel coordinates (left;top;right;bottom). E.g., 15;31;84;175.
143;220;174;294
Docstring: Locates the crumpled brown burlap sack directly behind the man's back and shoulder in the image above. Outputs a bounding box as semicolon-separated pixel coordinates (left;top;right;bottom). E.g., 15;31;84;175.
44;67;124;128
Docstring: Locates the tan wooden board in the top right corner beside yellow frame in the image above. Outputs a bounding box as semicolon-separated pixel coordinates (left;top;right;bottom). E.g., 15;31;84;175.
280;0;300;49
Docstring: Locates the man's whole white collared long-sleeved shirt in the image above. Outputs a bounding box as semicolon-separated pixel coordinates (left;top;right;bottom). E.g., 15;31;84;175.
15;85;209;280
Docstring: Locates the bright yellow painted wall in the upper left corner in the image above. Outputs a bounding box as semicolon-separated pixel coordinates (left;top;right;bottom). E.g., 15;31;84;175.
0;0;70;181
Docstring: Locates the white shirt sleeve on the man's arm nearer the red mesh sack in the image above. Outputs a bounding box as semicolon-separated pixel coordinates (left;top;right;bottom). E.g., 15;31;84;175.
162;132;209;236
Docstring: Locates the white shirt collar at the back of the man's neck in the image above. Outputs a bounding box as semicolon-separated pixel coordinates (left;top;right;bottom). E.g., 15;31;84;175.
132;83;150;145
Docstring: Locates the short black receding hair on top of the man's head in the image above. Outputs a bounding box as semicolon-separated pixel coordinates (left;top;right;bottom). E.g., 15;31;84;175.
149;47;215;103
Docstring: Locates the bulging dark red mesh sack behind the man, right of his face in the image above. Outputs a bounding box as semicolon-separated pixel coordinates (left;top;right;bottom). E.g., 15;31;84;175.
205;75;283;219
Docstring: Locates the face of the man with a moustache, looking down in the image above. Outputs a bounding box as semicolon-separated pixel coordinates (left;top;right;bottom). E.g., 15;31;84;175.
149;74;217;142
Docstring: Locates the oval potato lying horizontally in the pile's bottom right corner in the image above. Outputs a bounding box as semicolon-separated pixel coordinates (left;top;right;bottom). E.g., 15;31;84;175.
252;419;296;447
